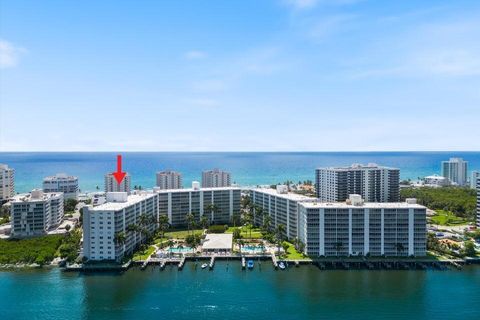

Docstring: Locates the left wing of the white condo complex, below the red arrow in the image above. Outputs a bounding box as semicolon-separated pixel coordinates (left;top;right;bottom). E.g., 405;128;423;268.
83;192;158;262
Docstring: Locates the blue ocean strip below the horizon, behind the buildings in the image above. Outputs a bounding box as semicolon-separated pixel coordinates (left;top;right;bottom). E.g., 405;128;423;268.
0;152;480;192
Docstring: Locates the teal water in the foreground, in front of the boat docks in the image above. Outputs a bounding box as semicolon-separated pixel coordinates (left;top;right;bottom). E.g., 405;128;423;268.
0;261;480;320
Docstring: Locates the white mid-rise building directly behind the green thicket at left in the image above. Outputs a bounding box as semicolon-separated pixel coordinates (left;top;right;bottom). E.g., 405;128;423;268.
11;189;63;238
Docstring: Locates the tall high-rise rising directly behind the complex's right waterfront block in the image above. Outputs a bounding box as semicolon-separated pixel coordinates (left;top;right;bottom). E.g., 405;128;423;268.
315;163;400;202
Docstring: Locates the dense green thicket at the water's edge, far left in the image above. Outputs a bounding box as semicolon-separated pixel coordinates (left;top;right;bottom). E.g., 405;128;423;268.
0;235;64;264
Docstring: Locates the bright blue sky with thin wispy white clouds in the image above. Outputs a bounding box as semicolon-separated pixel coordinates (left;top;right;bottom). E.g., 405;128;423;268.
0;0;480;151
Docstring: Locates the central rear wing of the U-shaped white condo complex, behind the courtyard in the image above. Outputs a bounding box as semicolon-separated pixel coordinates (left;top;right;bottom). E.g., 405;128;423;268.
154;181;241;227
